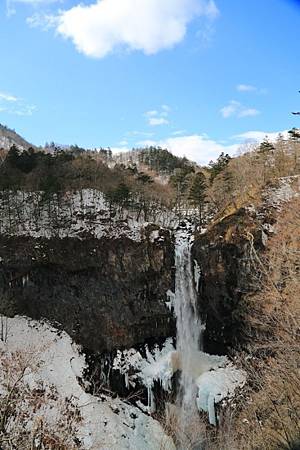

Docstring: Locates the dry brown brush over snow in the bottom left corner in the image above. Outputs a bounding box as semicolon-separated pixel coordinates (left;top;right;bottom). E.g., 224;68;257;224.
0;351;81;450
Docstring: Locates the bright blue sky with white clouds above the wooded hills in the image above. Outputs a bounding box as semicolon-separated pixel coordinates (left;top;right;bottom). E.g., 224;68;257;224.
0;0;300;163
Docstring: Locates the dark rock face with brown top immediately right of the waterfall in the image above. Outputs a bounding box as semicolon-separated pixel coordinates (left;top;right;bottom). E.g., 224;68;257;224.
193;209;263;354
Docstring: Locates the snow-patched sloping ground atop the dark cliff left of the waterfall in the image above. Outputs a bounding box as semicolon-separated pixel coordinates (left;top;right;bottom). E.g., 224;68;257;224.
0;189;175;241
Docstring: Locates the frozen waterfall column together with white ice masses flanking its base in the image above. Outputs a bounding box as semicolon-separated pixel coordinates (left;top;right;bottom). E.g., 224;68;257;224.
113;223;246;428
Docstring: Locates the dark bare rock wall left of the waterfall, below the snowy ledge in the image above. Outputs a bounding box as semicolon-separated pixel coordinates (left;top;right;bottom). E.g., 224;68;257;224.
0;188;175;353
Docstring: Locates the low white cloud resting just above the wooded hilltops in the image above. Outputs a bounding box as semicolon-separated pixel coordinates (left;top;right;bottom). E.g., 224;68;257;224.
137;134;239;164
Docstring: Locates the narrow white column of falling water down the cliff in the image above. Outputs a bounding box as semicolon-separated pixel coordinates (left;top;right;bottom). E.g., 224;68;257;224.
174;222;203;428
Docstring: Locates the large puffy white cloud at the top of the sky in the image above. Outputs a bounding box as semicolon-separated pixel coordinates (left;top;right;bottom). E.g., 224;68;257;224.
48;0;218;58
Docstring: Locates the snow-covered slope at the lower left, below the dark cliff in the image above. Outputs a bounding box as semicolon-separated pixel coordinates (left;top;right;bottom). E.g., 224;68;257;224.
0;317;175;450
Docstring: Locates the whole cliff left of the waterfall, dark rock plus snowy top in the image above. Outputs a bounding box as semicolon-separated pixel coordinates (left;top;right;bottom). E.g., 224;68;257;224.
0;190;175;353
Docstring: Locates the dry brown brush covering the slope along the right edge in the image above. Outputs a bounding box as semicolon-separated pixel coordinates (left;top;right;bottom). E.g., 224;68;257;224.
212;197;300;450
